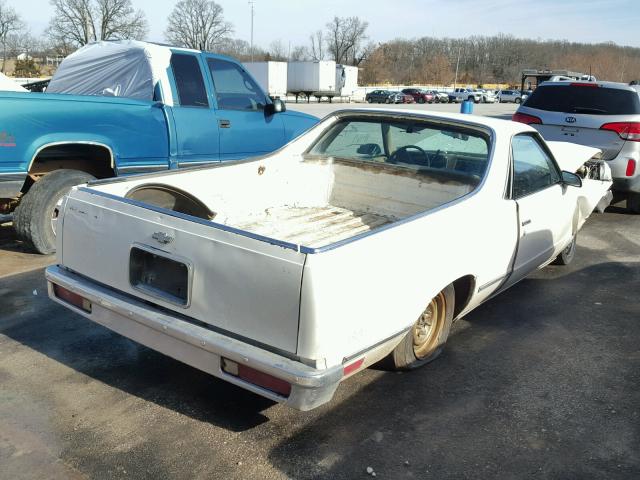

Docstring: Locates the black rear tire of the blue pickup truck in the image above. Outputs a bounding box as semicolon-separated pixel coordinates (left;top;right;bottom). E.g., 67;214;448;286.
13;169;95;254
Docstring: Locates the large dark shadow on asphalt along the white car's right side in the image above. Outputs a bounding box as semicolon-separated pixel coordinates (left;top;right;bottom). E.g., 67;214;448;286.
270;258;640;479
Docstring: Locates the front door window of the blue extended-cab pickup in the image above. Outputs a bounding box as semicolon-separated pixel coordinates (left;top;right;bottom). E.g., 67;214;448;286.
207;58;267;111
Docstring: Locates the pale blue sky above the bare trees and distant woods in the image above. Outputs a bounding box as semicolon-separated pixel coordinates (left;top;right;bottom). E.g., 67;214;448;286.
5;0;640;47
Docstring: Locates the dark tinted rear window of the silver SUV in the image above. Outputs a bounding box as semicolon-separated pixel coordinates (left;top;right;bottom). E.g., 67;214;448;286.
524;85;640;115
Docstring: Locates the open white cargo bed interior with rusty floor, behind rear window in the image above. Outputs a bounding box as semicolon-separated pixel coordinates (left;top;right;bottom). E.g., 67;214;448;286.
93;157;479;249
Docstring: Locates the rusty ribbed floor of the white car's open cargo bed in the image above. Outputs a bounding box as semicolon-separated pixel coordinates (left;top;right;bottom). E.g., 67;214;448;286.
236;205;394;247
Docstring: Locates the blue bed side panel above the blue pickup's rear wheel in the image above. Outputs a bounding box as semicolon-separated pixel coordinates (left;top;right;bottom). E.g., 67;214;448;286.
0;93;168;172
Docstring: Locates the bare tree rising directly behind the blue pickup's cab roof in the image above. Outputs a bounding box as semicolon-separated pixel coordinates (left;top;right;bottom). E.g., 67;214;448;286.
165;0;233;51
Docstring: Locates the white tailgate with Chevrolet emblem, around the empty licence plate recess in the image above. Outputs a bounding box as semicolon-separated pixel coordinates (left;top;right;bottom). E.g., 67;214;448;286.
58;188;305;353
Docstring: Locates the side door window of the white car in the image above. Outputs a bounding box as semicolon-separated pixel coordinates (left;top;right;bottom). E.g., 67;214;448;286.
511;134;560;199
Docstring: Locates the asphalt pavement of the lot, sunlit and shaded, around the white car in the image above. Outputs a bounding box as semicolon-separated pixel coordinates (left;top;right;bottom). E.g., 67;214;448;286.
0;105;640;480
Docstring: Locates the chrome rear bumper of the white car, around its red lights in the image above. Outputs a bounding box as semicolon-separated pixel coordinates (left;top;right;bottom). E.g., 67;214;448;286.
46;266;343;410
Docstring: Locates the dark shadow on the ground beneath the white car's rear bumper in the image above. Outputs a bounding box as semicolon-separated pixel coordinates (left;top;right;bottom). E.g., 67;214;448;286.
0;270;273;431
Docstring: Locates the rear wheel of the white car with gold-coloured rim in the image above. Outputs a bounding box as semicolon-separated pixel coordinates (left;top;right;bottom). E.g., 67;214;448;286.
390;285;456;370
